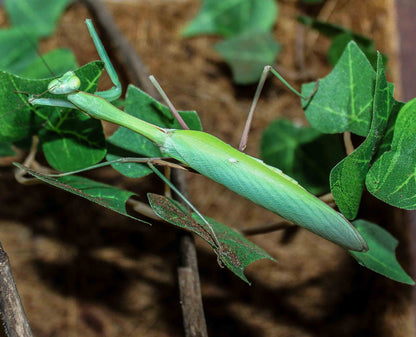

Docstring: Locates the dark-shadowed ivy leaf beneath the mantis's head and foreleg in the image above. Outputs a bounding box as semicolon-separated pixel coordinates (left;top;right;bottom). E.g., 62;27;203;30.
0;62;106;171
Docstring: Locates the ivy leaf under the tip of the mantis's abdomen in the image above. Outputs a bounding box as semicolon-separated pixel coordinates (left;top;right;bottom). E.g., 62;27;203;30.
350;220;415;285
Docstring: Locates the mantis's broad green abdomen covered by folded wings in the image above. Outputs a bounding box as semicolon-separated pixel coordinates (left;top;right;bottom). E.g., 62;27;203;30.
161;130;368;251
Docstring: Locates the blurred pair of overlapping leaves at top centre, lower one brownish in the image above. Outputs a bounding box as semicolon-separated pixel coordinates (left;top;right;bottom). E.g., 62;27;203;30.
183;0;280;84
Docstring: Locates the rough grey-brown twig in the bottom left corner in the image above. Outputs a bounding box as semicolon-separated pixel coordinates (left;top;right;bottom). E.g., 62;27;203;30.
0;243;33;337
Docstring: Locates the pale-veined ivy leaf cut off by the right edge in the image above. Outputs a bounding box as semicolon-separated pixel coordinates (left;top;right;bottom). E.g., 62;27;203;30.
366;99;416;209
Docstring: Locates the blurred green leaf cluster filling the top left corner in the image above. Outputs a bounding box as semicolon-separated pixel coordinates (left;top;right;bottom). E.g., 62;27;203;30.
0;0;77;78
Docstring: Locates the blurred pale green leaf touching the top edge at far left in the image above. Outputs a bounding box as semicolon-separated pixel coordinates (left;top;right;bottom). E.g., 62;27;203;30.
5;0;72;37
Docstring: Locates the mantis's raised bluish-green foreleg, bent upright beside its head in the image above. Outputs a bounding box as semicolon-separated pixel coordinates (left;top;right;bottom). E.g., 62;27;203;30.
85;19;121;102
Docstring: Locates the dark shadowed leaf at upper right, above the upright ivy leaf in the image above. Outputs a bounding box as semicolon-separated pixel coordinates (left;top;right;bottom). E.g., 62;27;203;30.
298;15;388;68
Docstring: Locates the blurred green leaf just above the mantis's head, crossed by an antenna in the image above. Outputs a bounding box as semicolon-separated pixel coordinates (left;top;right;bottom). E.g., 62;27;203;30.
19;48;78;78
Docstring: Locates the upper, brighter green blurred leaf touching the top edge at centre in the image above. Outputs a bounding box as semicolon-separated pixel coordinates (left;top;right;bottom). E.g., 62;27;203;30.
183;0;278;37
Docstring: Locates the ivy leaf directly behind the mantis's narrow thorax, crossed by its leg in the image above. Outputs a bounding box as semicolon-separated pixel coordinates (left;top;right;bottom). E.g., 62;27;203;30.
107;85;202;178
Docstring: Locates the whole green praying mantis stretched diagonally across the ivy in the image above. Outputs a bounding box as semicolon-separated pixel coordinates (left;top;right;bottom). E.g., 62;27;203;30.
24;20;368;252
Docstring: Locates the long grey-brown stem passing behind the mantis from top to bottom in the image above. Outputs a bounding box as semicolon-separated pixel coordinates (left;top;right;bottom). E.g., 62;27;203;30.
84;0;208;337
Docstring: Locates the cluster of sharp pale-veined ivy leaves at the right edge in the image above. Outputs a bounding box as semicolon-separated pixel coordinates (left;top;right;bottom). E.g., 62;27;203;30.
302;42;416;219
